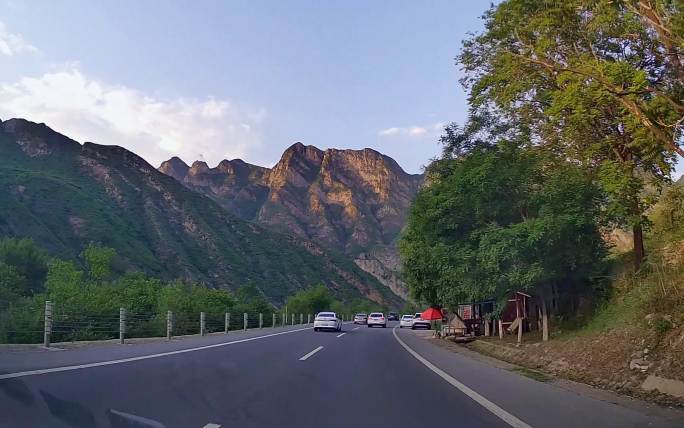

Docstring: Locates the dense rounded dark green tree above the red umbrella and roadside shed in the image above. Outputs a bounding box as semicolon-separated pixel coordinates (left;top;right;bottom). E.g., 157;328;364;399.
400;142;605;340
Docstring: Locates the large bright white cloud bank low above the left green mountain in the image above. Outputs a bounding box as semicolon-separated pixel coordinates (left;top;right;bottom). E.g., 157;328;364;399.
0;68;265;166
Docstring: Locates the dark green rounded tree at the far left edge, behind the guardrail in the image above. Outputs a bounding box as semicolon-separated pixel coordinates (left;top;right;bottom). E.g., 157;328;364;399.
0;238;48;296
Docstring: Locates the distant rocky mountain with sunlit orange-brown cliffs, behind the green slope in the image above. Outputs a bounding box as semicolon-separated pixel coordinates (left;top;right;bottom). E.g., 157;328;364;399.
159;143;423;299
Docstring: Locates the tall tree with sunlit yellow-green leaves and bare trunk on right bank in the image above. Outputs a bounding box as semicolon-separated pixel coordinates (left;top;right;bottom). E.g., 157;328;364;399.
458;0;684;269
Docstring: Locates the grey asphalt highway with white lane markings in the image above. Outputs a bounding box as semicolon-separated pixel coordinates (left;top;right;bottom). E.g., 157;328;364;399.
0;324;684;428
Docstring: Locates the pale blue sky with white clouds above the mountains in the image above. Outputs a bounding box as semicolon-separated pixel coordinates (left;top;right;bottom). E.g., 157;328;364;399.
0;0;490;172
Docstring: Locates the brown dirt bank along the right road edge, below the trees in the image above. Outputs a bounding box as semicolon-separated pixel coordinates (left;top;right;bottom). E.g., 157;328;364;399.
440;327;684;408
